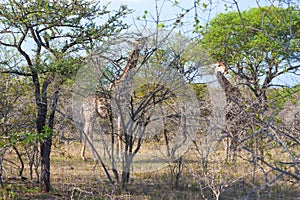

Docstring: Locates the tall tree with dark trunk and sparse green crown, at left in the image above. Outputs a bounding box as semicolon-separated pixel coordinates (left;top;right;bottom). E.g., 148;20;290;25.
0;0;129;192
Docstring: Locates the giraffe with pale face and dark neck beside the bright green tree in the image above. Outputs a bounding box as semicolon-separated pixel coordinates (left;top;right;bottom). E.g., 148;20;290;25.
214;62;243;162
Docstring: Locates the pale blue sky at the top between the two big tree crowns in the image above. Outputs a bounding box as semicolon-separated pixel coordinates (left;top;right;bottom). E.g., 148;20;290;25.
101;0;272;37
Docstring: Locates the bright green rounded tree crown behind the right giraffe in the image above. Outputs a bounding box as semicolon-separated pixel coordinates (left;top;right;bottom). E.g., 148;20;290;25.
201;6;300;101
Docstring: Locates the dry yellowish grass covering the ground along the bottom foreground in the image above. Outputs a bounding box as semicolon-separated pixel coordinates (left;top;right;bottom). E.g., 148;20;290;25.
0;138;300;200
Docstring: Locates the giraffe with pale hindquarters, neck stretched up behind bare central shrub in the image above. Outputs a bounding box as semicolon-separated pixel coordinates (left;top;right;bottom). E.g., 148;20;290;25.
81;38;146;160
